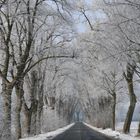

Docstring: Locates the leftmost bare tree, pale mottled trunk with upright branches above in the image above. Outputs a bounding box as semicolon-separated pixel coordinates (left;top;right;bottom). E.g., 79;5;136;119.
0;1;19;139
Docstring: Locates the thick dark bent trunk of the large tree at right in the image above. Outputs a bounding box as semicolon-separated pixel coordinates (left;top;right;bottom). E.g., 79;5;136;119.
123;64;137;133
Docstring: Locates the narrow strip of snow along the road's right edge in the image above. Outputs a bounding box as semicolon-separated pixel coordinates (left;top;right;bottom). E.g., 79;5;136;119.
84;123;140;140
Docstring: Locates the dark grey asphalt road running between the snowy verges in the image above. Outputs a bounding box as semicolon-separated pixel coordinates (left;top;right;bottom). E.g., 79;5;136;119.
50;123;115;140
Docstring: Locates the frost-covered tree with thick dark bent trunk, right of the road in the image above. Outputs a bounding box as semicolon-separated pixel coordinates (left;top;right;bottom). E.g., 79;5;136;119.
89;0;139;133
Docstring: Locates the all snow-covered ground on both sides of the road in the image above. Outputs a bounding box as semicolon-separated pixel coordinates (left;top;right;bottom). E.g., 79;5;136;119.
20;122;140;140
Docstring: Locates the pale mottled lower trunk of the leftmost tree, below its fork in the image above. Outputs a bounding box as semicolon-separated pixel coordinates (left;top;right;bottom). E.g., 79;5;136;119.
2;83;13;140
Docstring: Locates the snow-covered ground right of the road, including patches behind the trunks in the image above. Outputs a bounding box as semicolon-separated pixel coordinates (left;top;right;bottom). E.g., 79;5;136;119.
84;122;140;140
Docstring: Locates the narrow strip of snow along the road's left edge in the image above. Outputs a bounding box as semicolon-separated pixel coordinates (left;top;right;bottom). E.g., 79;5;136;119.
20;123;74;140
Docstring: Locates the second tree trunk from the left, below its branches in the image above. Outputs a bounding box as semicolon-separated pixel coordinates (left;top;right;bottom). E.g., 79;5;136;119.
15;79;24;140
